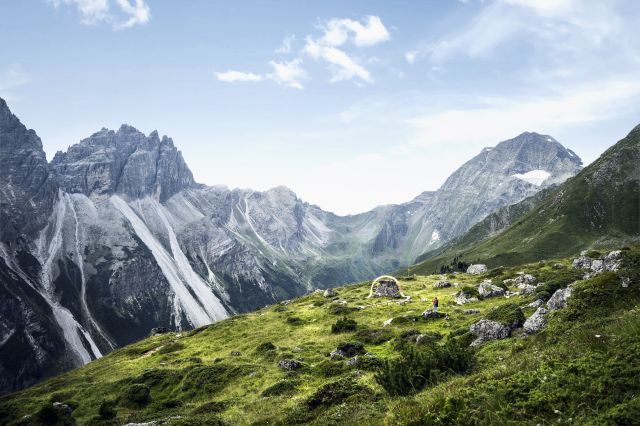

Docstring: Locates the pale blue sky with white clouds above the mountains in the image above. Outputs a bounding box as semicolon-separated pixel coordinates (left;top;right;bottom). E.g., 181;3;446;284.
0;0;640;214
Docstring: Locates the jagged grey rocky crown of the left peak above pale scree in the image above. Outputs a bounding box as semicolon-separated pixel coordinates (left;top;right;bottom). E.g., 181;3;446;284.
51;124;195;201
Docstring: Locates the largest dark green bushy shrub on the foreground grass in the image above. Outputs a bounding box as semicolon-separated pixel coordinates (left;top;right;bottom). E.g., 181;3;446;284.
375;340;475;395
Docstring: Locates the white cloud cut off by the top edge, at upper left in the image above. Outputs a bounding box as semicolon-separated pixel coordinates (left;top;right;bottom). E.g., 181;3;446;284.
50;0;151;30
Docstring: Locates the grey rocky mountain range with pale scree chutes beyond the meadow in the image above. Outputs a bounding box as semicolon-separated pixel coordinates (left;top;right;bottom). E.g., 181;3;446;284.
0;99;582;392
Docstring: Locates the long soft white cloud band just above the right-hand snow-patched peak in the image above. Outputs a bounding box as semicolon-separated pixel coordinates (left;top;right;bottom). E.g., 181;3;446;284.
407;77;640;146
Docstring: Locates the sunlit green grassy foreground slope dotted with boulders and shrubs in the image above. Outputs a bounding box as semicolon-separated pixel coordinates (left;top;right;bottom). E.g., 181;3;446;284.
0;248;640;425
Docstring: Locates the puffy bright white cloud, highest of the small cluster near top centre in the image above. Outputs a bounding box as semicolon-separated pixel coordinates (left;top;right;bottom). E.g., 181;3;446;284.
320;16;390;46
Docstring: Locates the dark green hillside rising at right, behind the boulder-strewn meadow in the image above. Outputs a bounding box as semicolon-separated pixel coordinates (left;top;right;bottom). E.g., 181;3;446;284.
411;126;640;274
